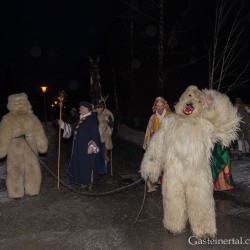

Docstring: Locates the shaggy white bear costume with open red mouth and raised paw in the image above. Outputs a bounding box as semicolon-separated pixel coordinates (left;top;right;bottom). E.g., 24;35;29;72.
141;85;240;238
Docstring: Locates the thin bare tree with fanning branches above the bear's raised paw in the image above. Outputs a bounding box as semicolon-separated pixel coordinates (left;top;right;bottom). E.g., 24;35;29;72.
209;0;249;93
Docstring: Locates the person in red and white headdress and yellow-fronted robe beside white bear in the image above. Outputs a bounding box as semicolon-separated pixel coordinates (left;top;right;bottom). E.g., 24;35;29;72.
143;96;172;192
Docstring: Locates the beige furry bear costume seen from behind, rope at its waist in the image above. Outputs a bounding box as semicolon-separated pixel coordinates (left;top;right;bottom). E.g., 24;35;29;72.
0;93;48;198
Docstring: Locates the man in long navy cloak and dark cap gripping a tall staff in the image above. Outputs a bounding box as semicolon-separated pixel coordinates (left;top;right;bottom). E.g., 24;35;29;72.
58;101;101;190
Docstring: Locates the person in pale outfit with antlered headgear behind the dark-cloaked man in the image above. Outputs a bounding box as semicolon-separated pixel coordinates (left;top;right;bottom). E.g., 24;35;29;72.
95;101;114;172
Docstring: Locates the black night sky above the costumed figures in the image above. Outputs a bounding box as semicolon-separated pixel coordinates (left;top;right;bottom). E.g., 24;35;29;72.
0;0;250;120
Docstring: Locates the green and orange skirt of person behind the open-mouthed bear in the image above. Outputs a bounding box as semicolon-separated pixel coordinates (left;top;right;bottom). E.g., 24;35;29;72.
211;143;234;191
